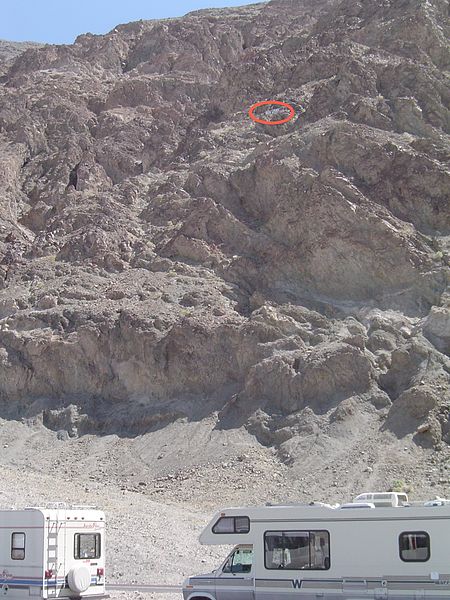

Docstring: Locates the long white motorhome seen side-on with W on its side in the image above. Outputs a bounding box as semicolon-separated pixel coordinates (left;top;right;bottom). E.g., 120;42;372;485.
183;492;450;600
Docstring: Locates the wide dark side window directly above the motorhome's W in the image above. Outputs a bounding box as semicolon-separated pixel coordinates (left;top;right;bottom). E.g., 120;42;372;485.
264;531;330;571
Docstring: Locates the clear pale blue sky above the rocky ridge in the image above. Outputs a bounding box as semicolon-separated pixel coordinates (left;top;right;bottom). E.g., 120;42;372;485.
0;0;264;44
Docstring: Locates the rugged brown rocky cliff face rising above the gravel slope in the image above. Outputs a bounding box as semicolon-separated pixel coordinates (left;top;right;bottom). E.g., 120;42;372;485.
0;0;450;494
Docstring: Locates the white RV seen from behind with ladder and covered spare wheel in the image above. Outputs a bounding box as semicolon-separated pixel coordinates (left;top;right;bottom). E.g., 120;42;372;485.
0;504;108;599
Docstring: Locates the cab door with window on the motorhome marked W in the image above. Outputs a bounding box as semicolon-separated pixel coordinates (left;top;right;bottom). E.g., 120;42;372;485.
216;546;255;600
